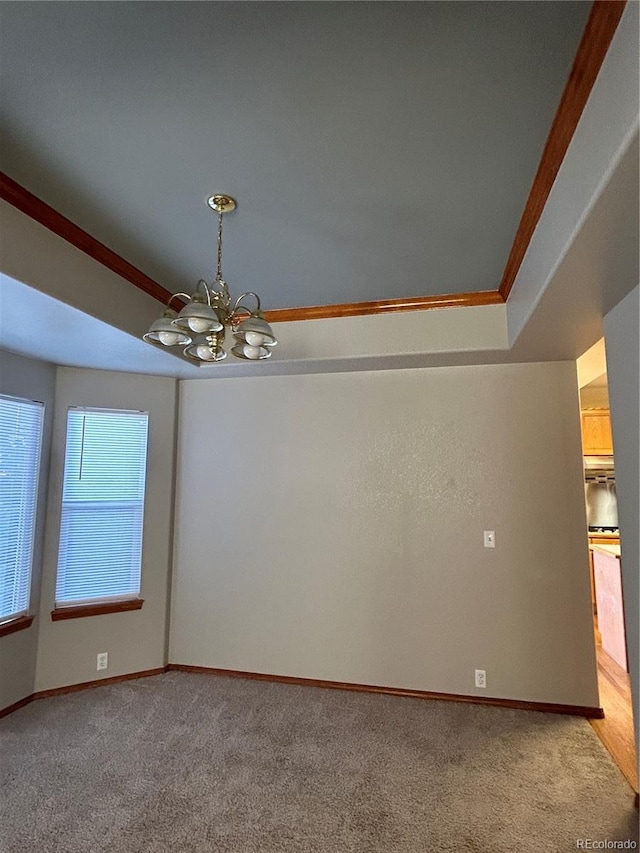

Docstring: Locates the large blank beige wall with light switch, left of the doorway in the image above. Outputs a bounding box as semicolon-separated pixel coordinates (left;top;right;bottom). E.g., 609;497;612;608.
169;362;598;706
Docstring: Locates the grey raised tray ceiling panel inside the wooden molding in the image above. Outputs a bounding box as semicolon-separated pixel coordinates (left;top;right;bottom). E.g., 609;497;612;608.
0;2;591;309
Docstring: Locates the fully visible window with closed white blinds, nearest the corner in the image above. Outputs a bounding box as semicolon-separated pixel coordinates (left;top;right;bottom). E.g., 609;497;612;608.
56;409;148;607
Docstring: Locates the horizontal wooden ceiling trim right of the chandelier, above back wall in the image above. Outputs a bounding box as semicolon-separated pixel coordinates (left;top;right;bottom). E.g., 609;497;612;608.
264;290;504;323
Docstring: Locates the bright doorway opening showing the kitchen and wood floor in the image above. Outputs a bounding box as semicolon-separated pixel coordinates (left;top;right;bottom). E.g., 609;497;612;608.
578;339;638;793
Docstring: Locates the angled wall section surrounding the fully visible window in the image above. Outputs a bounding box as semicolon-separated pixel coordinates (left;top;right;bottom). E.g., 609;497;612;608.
35;367;176;691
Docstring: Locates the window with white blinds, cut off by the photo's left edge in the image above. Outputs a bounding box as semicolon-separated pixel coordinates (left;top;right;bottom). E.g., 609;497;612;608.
0;396;44;622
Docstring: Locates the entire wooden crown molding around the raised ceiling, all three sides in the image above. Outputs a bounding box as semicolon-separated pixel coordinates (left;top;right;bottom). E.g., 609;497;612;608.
0;0;626;323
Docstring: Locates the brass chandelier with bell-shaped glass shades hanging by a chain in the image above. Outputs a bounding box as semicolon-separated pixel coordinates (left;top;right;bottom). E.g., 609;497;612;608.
142;194;277;364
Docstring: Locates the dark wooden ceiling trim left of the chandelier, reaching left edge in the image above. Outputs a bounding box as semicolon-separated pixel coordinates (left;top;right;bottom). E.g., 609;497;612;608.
0;172;171;304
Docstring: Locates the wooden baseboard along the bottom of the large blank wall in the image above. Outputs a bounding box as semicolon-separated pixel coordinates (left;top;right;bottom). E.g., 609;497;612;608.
166;663;604;719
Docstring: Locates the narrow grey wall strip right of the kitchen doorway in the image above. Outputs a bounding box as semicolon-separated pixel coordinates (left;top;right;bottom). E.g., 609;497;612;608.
604;287;640;758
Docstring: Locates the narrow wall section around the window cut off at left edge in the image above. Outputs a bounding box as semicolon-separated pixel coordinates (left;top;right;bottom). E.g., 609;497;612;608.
0;350;56;709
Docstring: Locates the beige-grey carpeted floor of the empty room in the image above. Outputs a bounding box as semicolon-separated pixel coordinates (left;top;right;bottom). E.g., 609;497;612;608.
0;672;638;853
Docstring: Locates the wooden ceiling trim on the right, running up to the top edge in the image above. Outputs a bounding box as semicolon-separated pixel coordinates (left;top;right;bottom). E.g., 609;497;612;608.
500;0;626;300
